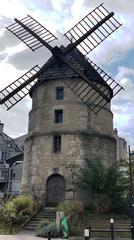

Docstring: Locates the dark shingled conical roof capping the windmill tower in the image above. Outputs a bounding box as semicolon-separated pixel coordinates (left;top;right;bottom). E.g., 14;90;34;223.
30;46;113;97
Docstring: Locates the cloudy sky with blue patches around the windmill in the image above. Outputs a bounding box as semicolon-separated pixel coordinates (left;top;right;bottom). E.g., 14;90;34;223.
0;0;134;148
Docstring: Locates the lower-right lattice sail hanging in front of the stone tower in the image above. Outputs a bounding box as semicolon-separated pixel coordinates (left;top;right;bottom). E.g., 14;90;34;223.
54;51;113;113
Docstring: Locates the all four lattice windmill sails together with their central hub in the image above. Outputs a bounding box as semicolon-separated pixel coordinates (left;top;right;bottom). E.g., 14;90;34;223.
0;4;122;114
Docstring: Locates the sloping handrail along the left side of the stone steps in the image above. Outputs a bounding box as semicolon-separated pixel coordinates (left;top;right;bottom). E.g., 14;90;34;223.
21;194;46;228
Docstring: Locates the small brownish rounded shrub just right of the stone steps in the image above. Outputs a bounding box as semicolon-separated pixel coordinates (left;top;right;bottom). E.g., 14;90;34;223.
58;200;84;221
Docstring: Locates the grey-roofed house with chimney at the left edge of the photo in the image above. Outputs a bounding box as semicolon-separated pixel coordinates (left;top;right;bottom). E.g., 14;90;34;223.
0;121;23;196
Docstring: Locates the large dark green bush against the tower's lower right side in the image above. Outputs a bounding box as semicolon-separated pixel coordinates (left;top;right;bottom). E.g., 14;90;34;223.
78;160;126;214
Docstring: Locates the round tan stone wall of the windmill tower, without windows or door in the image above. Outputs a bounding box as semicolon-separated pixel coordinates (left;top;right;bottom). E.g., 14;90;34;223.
22;80;116;203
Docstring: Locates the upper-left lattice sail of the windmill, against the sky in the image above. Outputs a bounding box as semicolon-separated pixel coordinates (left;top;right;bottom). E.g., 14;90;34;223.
7;15;57;51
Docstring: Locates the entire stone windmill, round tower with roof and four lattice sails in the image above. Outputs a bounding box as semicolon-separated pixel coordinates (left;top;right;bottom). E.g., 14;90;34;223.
0;4;122;206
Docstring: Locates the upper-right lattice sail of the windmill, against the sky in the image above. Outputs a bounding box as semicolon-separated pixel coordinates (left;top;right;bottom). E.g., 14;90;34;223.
64;4;121;55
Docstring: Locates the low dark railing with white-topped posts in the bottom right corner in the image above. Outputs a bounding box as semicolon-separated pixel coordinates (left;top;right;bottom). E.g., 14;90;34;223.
84;219;134;240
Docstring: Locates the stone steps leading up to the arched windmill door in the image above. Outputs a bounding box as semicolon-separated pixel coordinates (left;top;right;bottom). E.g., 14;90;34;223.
24;207;56;231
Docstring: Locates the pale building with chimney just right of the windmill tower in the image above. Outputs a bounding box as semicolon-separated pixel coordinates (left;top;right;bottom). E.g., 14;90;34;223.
113;128;127;161
